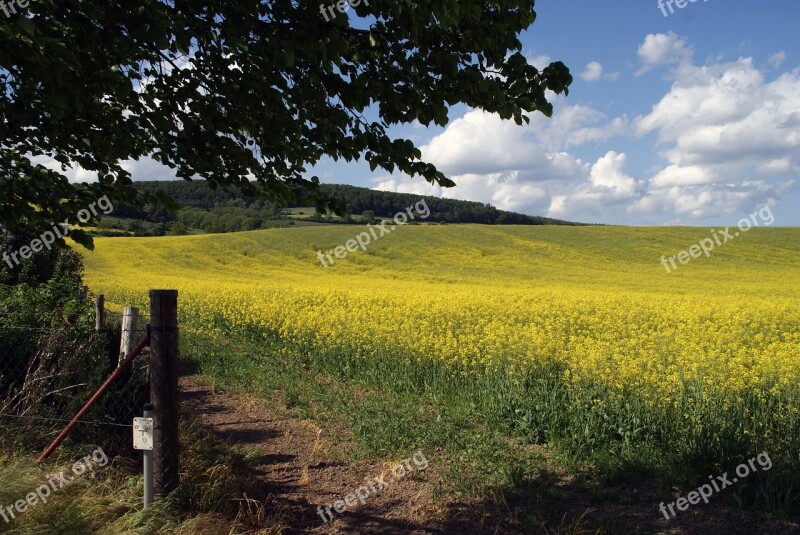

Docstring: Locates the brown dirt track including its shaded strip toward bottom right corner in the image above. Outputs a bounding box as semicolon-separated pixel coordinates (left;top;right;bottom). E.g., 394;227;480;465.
180;376;800;535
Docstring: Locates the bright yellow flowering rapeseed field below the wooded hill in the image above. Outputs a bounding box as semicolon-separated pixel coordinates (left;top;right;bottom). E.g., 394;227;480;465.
85;225;800;411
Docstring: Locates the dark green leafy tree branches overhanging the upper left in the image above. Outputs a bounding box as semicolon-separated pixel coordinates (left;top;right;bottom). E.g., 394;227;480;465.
0;0;572;244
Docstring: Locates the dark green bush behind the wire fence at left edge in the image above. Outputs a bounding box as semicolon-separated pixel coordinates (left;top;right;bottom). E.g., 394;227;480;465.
0;241;148;450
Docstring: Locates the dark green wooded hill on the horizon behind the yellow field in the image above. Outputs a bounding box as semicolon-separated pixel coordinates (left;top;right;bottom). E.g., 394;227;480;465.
107;180;579;234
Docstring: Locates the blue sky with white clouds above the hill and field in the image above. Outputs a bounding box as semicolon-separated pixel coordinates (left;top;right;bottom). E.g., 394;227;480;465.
64;0;800;226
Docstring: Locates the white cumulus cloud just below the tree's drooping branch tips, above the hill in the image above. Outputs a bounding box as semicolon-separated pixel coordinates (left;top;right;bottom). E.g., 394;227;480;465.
377;101;627;213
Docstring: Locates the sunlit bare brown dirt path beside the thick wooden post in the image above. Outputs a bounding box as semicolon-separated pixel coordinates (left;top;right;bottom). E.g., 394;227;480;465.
180;376;450;535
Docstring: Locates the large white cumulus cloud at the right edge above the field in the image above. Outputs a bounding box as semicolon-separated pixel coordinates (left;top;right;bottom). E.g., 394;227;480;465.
628;48;800;218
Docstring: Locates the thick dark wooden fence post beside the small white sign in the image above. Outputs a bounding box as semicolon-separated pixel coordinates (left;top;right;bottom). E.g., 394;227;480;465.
150;290;179;496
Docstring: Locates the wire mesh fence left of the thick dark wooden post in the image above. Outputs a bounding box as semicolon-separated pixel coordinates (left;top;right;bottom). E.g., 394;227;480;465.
0;305;149;454
